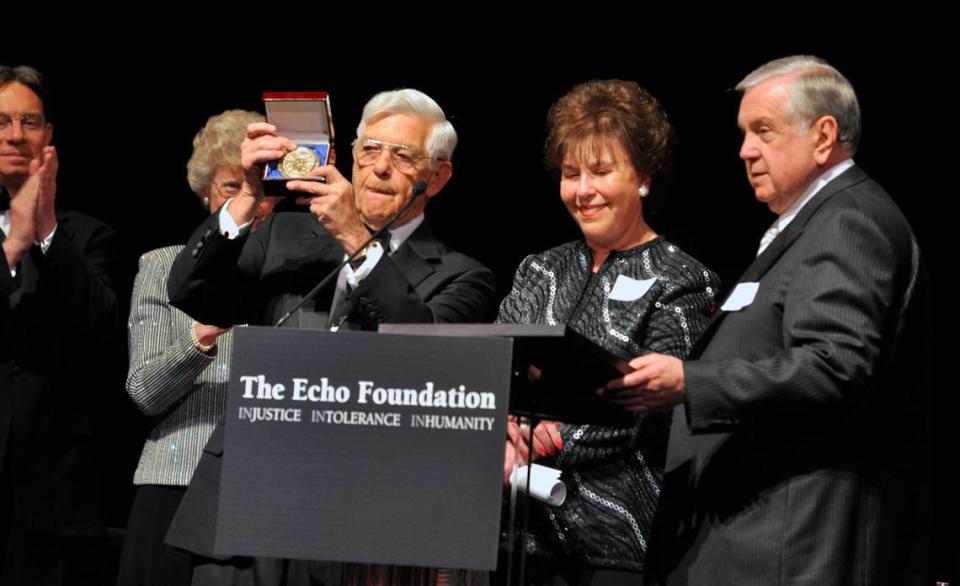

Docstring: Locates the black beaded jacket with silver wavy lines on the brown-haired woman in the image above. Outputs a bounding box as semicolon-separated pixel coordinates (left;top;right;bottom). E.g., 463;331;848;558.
498;238;719;571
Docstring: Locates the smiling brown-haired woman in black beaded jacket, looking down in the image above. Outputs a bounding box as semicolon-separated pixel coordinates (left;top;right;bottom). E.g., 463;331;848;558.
498;80;719;584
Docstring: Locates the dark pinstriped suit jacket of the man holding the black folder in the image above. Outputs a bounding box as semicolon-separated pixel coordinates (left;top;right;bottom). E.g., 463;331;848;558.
650;167;932;586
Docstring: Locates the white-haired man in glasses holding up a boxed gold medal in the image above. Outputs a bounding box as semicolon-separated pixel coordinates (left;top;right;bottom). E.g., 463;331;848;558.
167;89;494;584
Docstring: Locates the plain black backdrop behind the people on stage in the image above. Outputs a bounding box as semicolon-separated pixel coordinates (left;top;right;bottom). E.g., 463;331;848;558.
0;26;960;579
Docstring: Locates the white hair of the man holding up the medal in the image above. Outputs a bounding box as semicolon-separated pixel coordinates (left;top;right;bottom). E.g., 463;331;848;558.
357;88;457;161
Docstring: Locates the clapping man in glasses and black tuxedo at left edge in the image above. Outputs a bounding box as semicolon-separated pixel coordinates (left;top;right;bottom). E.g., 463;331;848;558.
0;66;120;585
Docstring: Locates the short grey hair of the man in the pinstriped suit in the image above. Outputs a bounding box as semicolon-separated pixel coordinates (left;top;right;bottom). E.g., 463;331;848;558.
736;55;860;153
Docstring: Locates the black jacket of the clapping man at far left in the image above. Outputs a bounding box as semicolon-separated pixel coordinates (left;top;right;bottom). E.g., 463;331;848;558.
0;212;121;535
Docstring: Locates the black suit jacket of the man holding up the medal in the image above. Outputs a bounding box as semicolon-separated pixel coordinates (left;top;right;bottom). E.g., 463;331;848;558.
167;213;494;557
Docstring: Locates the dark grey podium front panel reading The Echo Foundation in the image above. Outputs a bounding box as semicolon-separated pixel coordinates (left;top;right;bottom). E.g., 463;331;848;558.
215;327;512;570
